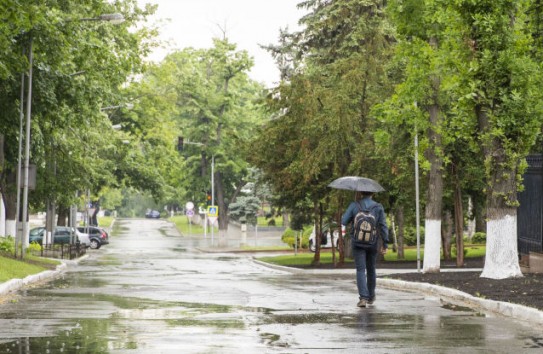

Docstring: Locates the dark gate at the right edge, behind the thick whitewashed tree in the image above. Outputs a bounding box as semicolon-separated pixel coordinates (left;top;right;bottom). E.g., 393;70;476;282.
517;154;543;256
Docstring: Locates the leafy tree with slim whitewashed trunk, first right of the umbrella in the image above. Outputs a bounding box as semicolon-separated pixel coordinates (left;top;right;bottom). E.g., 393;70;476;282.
389;0;460;272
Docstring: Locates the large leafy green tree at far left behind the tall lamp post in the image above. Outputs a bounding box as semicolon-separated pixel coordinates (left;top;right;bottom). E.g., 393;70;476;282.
0;0;157;238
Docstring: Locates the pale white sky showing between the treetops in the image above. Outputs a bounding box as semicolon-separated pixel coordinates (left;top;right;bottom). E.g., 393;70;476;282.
138;0;304;87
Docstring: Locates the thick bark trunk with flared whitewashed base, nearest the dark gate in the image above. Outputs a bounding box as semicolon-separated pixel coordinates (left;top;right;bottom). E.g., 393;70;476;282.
476;106;522;279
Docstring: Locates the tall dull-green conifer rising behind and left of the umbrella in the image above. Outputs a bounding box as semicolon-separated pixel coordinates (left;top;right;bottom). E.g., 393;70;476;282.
255;0;393;263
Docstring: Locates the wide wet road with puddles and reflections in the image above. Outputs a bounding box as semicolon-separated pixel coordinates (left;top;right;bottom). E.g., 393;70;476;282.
0;220;543;354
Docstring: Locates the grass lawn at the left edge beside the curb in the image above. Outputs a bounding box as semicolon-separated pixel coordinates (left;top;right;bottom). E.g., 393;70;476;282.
0;255;60;282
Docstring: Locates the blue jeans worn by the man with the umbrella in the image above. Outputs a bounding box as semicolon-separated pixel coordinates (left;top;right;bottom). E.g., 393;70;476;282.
353;247;377;300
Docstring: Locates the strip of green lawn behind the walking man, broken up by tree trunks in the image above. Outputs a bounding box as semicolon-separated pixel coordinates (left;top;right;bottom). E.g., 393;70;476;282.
258;245;486;266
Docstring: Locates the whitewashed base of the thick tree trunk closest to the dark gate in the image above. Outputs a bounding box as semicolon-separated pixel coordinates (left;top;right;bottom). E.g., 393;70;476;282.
481;215;522;279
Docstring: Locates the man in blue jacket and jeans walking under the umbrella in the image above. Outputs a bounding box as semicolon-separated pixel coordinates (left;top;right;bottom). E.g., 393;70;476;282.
341;192;388;307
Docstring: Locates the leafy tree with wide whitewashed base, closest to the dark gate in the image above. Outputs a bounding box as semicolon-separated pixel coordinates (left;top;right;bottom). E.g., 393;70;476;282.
452;0;543;279
